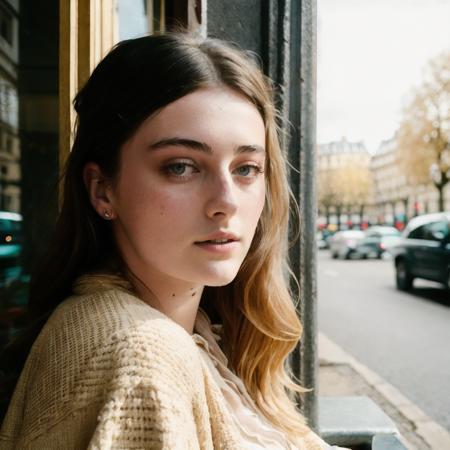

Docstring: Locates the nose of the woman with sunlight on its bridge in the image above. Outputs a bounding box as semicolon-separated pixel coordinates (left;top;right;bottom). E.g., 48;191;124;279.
205;174;238;219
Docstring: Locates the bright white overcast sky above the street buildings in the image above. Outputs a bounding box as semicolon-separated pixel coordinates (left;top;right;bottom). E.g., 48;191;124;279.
317;0;450;153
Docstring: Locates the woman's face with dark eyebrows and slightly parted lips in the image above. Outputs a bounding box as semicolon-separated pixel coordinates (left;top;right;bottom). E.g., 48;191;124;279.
111;87;265;286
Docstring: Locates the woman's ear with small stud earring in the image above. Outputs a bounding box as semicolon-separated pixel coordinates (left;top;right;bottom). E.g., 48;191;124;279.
83;162;116;220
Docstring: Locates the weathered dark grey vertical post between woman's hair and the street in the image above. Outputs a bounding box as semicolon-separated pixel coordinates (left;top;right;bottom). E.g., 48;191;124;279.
288;0;317;428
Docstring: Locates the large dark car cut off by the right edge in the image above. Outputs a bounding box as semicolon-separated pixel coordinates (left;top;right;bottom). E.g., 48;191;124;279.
392;211;450;290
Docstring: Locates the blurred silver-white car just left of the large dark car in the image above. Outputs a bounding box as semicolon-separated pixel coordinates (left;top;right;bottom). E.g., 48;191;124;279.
355;226;401;259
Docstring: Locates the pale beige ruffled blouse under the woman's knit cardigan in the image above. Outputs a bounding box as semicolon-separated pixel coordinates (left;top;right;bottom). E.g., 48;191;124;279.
192;308;338;450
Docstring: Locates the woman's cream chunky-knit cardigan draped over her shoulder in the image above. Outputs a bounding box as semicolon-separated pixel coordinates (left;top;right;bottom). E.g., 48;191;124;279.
0;276;328;450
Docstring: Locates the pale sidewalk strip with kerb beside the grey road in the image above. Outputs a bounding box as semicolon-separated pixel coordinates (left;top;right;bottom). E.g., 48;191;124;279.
319;333;450;450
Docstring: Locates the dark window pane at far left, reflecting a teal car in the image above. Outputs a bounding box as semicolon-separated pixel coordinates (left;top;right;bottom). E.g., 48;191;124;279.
0;0;59;345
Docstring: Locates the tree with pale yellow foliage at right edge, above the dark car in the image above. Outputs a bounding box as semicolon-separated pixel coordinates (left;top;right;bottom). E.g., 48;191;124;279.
397;52;450;211
